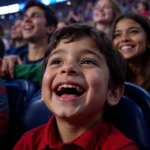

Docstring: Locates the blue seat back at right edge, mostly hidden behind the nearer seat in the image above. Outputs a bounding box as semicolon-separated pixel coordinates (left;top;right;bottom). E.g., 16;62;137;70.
124;82;150;130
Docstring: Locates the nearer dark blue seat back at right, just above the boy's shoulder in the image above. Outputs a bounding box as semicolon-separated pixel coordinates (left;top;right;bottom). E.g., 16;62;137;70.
105;96;150;150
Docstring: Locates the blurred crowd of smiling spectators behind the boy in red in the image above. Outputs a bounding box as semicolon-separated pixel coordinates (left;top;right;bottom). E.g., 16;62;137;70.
0;0;150;149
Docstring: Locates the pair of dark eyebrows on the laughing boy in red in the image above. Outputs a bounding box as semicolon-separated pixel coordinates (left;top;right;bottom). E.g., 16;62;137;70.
50;49;102;60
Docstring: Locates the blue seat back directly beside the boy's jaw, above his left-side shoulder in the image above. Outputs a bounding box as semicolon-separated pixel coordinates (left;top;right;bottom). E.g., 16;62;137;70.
23;95;52;132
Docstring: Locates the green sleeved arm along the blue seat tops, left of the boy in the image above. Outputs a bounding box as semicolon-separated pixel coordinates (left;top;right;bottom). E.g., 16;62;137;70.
14;64;42;85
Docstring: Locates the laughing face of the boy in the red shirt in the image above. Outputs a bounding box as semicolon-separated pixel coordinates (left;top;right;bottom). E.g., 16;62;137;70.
42;37;120;119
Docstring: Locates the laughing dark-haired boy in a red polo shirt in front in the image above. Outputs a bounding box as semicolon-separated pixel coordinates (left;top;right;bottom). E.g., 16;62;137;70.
14;24;137;150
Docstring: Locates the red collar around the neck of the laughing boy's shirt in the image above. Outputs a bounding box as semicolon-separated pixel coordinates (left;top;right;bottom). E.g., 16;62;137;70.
39;115;109;150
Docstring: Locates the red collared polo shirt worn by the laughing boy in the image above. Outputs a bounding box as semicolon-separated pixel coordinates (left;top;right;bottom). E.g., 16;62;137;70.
14;116;138;150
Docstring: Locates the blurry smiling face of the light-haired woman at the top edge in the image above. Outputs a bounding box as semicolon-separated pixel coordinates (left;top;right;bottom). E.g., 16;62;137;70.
93;0;113;23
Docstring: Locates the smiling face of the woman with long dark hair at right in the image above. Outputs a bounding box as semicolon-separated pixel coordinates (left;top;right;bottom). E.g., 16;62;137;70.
113;18;147;59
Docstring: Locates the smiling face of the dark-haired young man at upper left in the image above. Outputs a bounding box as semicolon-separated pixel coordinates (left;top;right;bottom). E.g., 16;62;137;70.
22;6;48;41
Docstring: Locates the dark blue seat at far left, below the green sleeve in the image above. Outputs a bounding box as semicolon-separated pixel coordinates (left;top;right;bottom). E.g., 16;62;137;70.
3;80;36;149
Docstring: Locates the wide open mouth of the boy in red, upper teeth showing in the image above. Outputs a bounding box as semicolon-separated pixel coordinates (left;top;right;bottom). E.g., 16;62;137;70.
55;84;85;97
